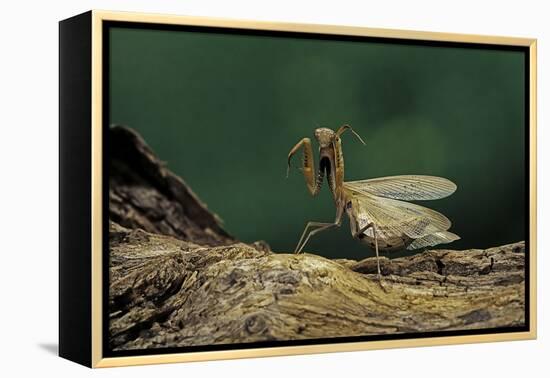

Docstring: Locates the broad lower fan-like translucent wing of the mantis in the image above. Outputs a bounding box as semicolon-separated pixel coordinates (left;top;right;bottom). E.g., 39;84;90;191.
346;188;451;239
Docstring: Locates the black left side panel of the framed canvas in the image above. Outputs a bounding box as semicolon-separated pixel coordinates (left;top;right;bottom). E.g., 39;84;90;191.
59;11;92;367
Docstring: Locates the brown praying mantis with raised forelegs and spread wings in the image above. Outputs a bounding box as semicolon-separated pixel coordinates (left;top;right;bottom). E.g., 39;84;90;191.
287;125;460;279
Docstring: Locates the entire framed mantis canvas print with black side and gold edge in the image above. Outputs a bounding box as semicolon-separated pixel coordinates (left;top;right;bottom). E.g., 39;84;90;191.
59;11;536;367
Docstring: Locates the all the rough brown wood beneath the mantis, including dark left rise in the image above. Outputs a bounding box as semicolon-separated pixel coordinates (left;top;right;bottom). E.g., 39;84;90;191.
109;128;525;350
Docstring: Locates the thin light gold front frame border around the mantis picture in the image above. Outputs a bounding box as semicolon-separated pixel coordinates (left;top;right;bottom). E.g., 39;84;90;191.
91;10;537;367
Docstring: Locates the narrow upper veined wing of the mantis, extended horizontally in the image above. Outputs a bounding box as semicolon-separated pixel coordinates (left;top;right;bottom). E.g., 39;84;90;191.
344;175;456;201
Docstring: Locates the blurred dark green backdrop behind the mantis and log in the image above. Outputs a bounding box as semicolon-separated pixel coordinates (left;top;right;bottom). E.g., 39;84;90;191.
109;27;525;258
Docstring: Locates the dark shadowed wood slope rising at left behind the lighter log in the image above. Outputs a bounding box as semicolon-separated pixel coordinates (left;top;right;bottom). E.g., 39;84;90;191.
109;126;235;245
